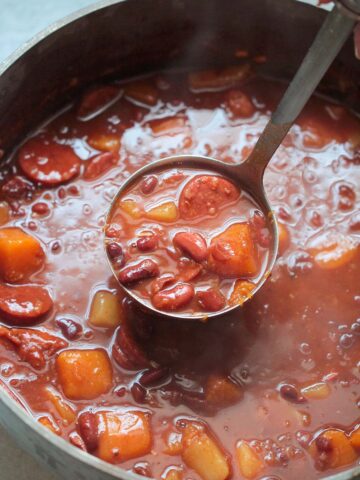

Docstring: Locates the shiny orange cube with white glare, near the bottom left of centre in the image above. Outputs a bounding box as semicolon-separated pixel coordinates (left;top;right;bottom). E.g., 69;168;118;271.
97;411;152;463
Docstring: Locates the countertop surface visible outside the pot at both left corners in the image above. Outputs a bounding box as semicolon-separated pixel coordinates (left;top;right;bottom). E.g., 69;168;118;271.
0;0;95;480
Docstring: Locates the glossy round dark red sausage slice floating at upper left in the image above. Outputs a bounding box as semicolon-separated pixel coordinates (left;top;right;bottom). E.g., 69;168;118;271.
18;136;80;187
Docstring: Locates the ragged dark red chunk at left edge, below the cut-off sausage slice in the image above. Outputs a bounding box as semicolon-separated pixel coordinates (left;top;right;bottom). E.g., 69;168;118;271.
0;326;67;369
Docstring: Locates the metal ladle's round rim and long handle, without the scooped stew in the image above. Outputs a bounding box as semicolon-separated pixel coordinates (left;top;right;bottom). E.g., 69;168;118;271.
107;0;360;320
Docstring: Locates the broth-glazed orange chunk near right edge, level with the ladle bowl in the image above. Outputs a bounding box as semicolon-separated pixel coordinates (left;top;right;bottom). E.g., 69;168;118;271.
309;231;358;270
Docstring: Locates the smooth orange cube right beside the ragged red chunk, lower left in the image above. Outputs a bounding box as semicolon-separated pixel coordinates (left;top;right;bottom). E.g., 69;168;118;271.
56;348;112;400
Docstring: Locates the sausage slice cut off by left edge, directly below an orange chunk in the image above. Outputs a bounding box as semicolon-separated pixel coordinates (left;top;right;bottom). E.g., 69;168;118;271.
0;285;53;325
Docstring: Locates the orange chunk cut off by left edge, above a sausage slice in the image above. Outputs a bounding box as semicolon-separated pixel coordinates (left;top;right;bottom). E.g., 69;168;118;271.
0;227;45;283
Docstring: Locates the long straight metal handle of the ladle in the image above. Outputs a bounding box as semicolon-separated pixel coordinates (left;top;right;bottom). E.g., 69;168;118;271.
246;4;360;178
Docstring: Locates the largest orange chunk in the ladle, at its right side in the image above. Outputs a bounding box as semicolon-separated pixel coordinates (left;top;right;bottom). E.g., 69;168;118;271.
209;223;259;278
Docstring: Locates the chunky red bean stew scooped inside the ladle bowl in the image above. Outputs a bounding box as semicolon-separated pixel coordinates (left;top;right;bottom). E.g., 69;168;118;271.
105;168;270;317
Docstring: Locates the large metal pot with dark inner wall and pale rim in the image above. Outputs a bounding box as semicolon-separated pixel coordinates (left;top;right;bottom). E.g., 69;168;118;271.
0;0;360;480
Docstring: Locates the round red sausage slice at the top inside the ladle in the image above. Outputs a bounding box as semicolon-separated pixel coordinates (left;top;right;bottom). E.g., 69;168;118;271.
179;175;240;220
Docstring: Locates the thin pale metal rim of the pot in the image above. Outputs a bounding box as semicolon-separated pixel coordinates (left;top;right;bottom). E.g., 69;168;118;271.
0;0;360;480
